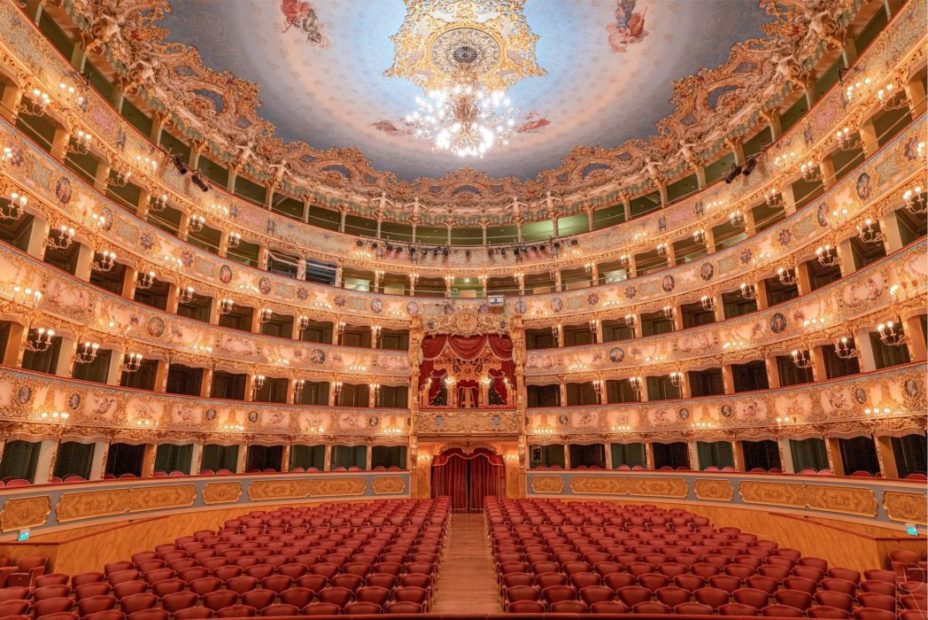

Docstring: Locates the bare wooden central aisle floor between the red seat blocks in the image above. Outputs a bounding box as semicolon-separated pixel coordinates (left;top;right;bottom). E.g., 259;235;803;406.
432;513;501;614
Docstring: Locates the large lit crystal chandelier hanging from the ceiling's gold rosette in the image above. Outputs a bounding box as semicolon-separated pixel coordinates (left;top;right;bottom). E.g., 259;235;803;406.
406;70;516;157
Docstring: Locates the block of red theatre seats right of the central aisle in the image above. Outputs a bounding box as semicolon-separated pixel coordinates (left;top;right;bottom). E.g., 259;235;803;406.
485;498;928;619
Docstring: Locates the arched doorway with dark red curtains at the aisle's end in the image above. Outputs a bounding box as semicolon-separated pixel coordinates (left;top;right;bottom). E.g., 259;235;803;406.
432;448;506;512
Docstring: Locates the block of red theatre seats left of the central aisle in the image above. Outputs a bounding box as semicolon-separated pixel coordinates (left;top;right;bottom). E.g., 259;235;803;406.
0;498;450;620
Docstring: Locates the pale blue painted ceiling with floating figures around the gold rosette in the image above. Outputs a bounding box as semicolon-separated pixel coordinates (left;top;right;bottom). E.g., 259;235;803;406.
158;0;772;179
